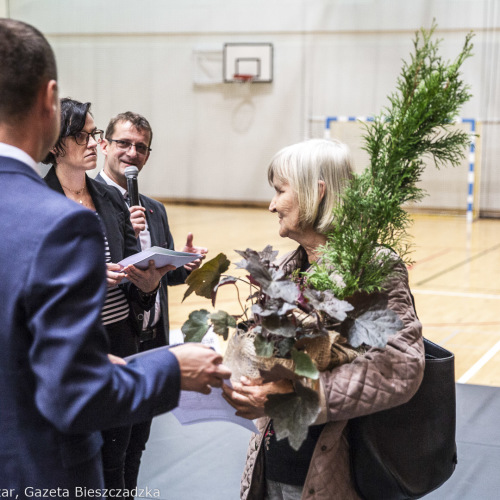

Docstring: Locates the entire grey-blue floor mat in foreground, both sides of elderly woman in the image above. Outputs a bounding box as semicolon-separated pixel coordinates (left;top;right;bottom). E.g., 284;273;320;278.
139;384;500;500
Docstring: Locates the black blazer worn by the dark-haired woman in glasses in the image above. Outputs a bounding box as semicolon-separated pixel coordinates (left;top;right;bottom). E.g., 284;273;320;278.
44;167;156;316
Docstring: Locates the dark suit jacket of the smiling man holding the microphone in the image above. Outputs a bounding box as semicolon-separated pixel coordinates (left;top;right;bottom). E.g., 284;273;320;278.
95;170;189;347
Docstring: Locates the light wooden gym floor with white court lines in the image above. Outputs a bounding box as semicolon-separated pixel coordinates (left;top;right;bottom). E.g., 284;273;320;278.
167;205;500;386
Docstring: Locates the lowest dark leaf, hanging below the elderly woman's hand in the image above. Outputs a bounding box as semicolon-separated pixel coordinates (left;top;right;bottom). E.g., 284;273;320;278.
265;382;320;450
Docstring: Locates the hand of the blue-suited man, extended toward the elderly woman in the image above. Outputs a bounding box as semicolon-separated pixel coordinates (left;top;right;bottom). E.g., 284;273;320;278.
170;343;231;394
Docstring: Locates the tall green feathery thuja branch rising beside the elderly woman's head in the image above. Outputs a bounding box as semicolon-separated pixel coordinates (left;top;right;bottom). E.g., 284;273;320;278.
308;24;473;298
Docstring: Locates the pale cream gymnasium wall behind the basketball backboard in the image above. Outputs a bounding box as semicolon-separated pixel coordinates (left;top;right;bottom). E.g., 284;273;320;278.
7;0;500;215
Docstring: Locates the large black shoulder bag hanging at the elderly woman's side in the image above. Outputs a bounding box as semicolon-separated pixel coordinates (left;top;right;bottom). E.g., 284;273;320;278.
349;338;457;500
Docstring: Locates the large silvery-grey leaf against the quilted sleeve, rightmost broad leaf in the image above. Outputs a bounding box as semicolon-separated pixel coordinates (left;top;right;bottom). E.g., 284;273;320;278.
348;309;403;348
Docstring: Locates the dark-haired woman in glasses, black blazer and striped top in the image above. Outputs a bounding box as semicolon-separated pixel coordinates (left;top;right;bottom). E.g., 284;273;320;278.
43;98;172;489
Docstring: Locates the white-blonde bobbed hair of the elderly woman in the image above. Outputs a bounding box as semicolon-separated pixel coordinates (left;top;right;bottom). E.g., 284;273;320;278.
267;139;353;233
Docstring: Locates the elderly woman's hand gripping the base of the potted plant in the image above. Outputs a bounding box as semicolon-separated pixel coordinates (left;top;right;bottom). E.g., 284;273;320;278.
222;377;293;420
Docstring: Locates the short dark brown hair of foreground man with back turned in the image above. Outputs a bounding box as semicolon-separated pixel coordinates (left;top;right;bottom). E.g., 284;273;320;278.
0;19;57;122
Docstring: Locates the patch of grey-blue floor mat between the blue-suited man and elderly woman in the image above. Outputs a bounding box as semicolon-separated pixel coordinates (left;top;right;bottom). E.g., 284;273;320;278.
138;414;251;500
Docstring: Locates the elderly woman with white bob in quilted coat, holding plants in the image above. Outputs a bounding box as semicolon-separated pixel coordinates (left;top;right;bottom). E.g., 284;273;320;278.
224;139;424;500
